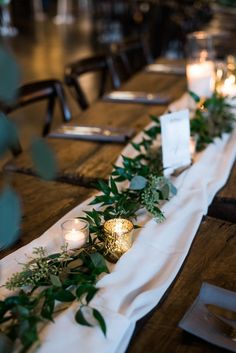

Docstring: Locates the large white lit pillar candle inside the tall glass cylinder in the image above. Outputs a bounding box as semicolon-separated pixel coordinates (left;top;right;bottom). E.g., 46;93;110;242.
186;61;215;97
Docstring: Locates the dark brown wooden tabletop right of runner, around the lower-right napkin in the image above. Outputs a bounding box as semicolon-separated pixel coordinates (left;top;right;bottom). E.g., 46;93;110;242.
127;217;236;353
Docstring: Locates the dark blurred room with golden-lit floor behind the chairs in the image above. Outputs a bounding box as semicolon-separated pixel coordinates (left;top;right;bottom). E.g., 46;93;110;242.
0;0;236;154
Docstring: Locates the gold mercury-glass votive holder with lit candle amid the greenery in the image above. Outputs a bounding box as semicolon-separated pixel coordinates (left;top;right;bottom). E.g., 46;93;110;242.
103;218;134;262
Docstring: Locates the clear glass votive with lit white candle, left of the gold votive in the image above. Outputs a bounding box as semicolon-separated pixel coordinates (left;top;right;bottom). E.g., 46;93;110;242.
61;218;89;250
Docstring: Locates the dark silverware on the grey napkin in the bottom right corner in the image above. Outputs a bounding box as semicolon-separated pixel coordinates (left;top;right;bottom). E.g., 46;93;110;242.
205;311;236;341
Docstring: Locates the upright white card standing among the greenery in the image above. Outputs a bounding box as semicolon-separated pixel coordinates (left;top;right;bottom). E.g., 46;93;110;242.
160;109;191;176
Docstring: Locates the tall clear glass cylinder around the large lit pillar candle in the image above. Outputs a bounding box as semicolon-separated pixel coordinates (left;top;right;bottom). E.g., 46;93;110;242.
186;32;215;98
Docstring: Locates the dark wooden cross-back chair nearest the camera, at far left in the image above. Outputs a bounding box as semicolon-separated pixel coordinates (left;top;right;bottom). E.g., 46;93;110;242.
4;79;71;156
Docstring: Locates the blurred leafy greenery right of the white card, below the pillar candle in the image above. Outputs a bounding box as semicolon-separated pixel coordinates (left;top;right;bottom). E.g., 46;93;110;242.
189;92;236;151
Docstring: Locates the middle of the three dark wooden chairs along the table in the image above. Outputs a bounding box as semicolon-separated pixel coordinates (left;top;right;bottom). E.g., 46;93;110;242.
65;55;121;110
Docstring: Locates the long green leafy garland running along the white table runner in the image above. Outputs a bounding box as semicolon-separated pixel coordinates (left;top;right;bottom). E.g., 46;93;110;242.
0;93;235;353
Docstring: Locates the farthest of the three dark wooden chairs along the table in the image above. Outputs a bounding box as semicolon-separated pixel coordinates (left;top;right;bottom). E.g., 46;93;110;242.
110;38;153;78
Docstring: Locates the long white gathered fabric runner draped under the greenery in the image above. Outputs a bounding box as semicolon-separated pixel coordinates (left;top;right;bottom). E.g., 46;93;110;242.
0;94;236;353
